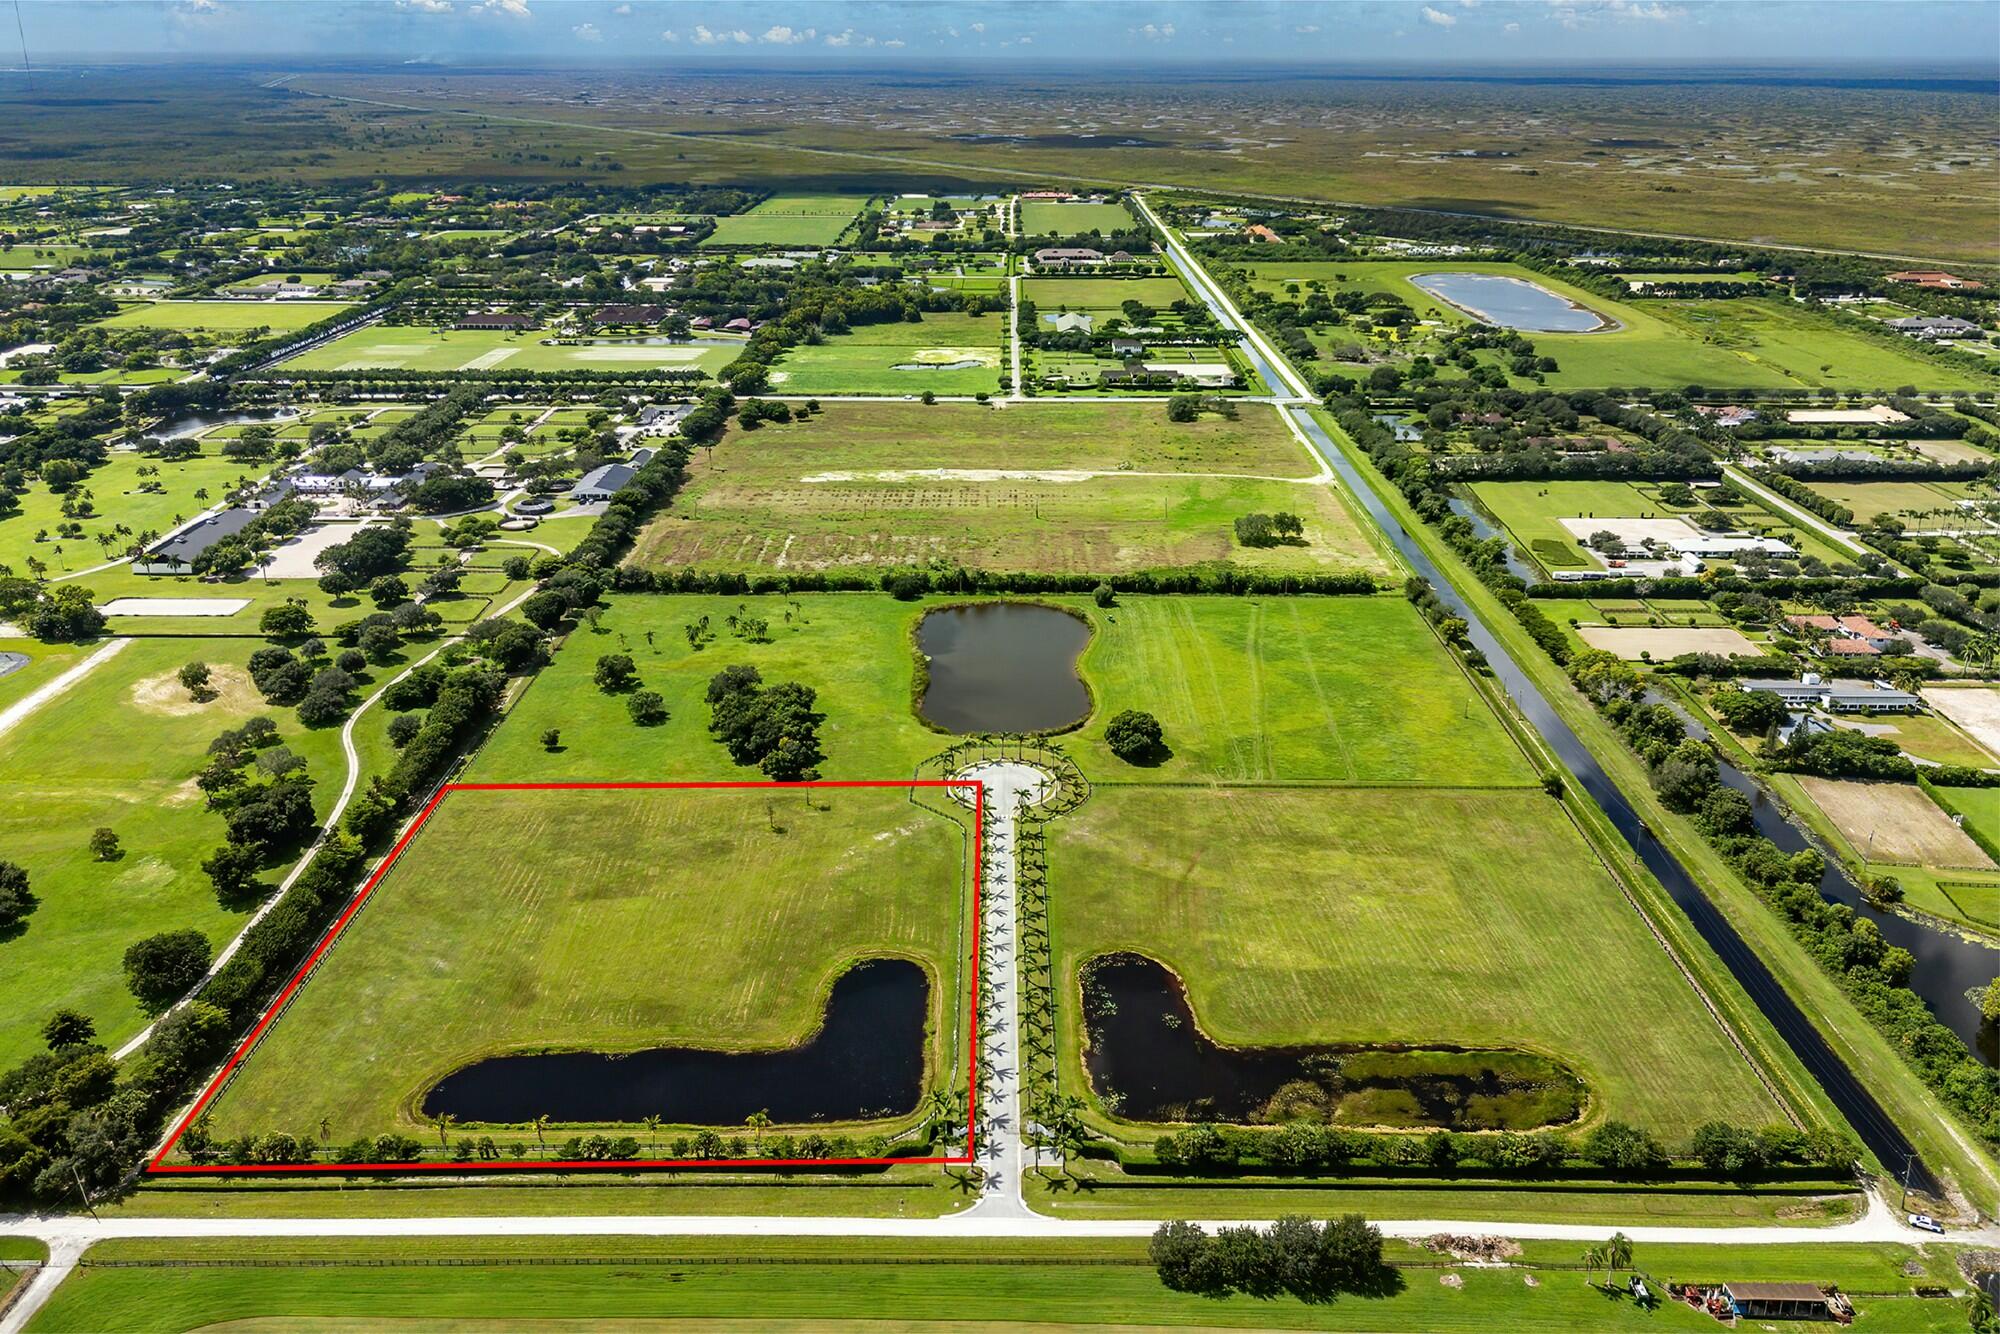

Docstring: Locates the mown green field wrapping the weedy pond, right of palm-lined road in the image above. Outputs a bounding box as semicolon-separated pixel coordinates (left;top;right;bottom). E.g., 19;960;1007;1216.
1050;786;1778;1136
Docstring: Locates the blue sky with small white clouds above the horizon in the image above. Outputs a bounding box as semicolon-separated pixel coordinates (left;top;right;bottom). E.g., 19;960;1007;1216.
11;0;2000;74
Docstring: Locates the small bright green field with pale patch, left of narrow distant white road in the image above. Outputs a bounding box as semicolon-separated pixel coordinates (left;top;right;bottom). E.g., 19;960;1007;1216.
770;312;1008;396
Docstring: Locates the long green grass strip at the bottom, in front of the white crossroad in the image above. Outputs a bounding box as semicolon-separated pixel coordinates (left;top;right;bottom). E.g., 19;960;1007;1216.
28;1236;1964;1334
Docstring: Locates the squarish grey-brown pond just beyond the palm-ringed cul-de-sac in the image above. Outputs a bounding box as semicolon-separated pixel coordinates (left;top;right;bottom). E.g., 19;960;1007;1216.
916;602;1090;732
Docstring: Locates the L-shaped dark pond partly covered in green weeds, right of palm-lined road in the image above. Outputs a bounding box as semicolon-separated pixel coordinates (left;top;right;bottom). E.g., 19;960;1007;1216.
1084;954;1584;1130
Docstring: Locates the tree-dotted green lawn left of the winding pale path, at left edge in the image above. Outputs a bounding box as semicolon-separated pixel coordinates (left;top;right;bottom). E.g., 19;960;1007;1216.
0;640;346;1068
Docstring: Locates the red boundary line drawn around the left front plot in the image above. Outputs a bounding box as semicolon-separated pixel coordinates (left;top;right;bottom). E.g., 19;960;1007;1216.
146;778;986;1176
